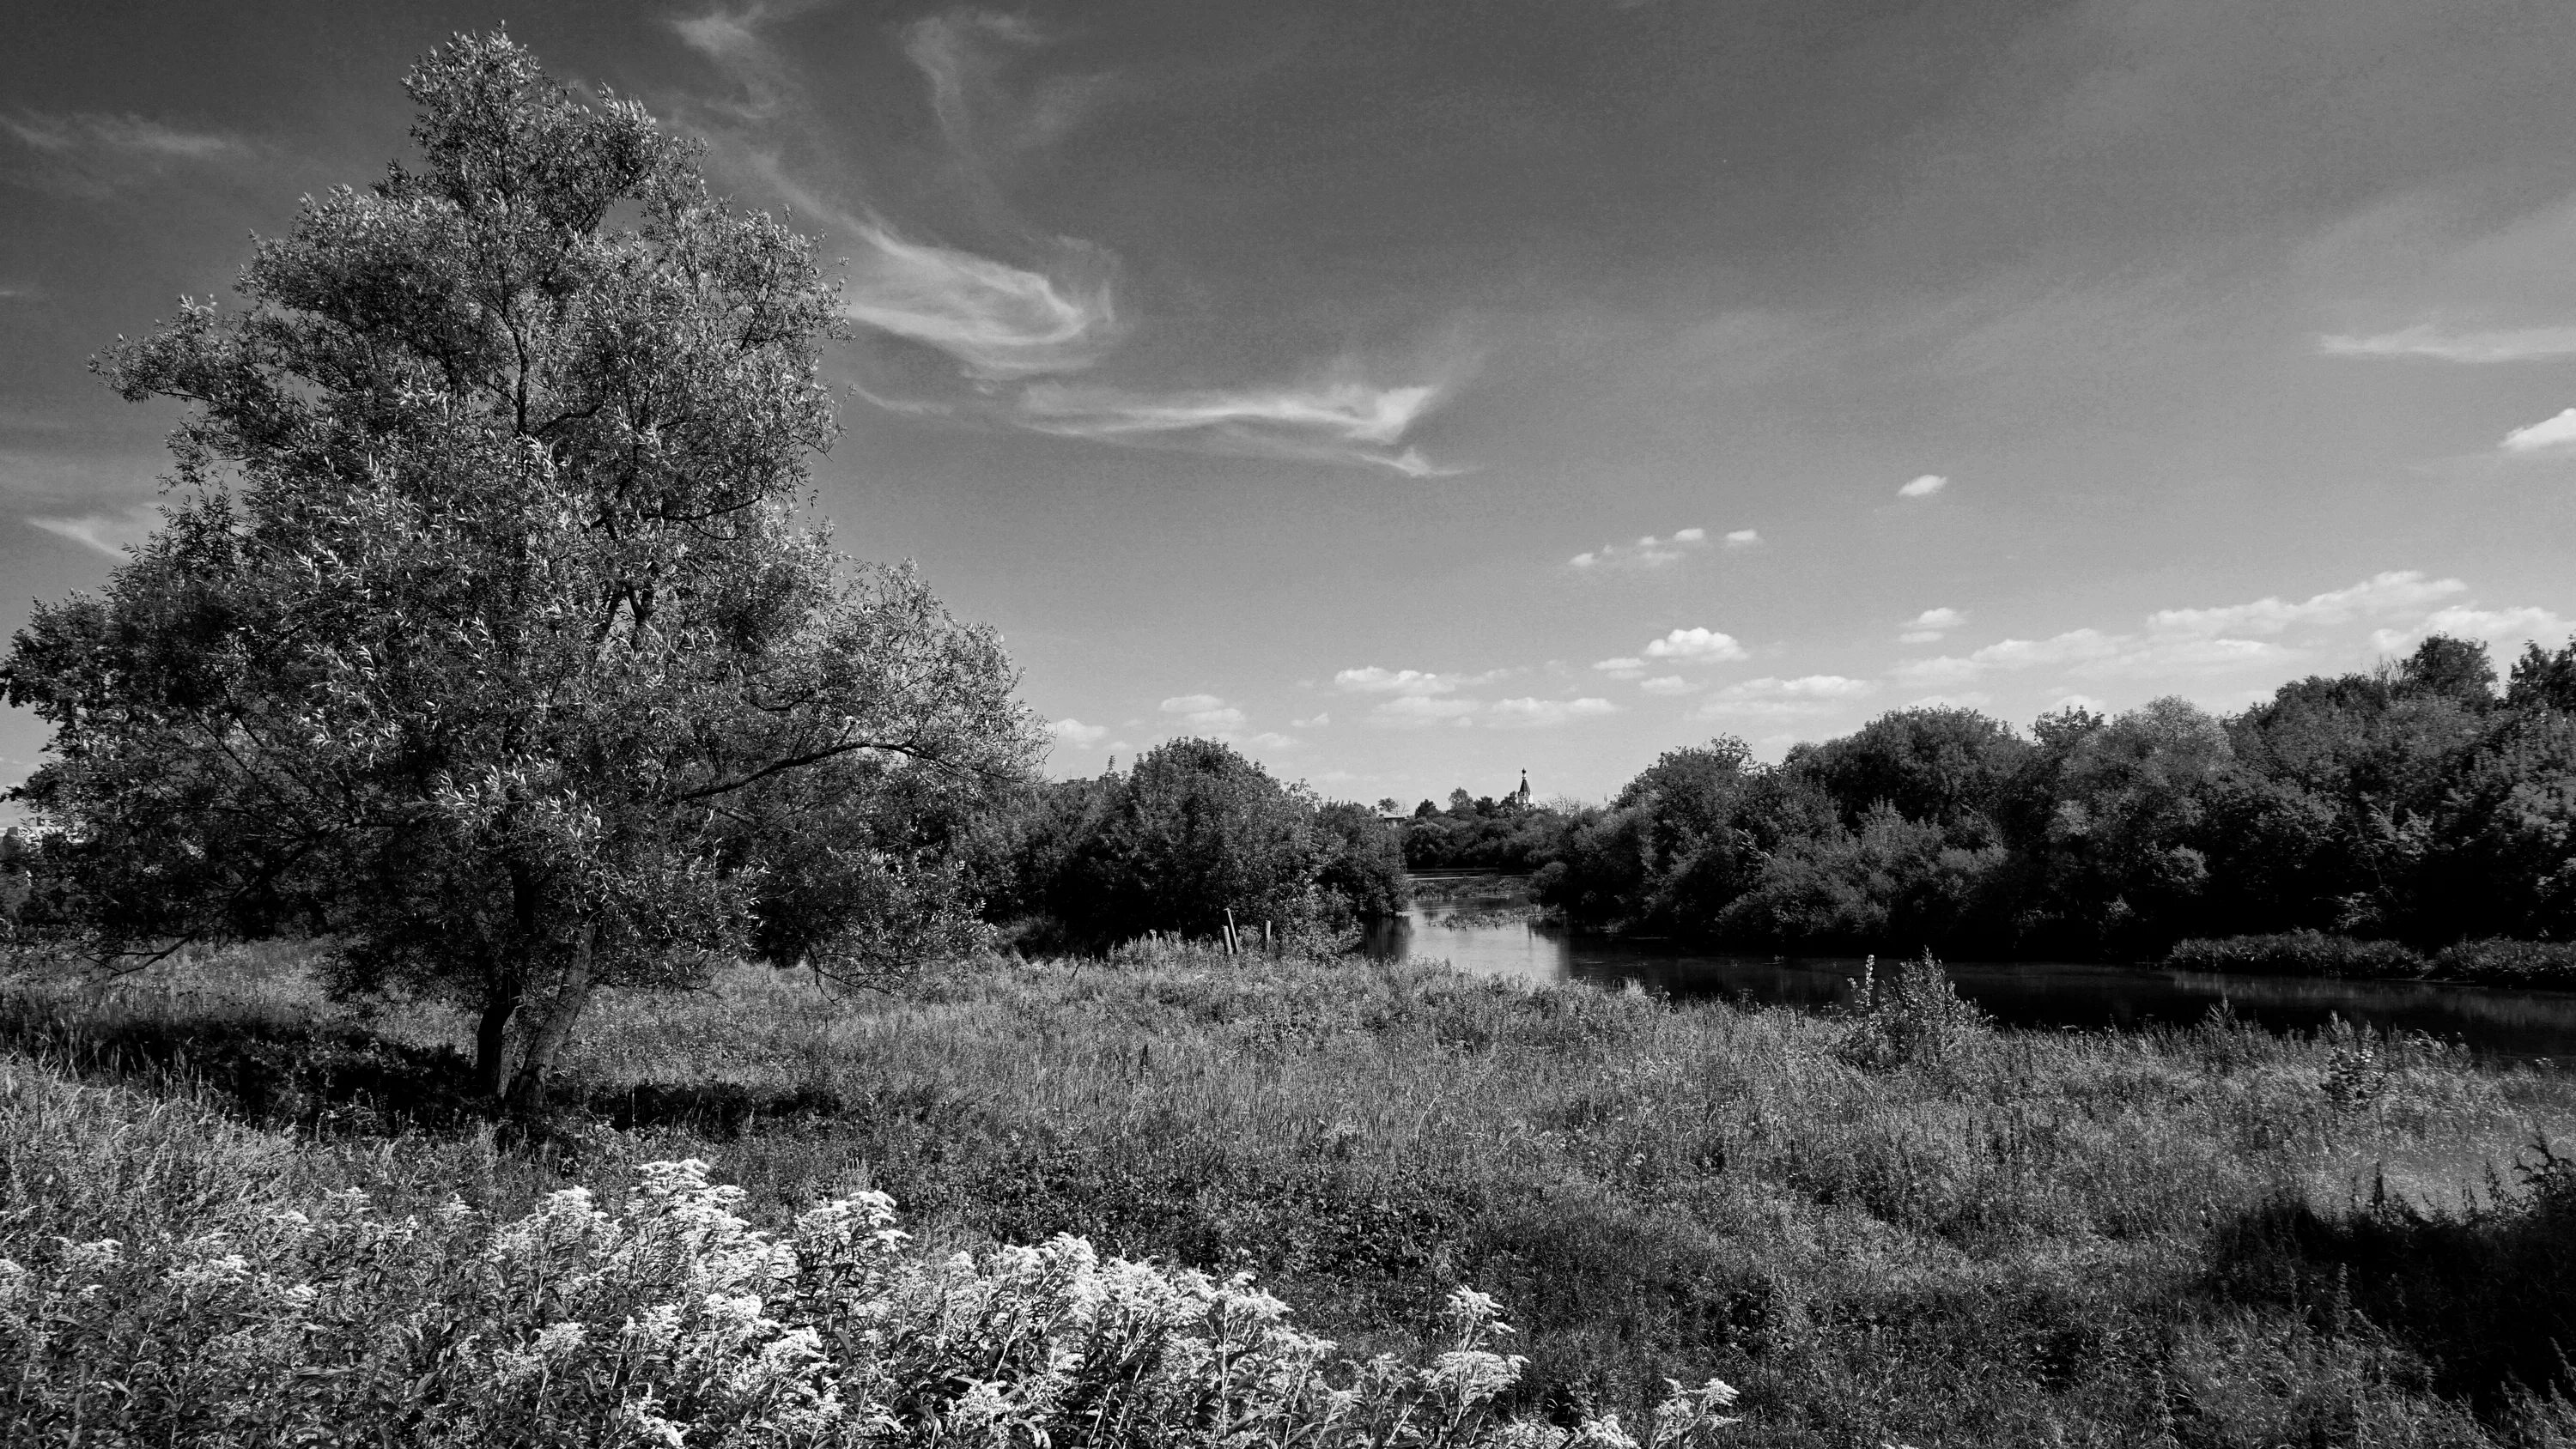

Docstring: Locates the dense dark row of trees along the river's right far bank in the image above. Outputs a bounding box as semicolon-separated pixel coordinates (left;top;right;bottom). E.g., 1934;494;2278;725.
1530;639;2576;957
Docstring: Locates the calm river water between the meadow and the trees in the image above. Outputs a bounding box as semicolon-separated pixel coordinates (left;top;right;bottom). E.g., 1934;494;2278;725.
1370;893;2576;1058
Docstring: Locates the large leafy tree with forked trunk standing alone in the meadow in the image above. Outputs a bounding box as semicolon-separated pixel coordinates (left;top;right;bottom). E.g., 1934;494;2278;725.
5;36;1033;1096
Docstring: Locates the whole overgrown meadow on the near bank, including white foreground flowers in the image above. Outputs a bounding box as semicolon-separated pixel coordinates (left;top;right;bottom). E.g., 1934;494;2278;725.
0;947;2576;1449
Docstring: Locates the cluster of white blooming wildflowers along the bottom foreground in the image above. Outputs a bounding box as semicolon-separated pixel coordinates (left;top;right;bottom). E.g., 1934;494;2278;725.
0;1161;1734;1449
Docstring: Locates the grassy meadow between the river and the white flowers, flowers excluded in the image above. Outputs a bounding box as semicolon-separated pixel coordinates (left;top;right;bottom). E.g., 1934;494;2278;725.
0;949;2576;1449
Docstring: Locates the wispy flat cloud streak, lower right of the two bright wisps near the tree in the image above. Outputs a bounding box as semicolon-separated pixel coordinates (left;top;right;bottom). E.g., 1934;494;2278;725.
1010;381;1461;479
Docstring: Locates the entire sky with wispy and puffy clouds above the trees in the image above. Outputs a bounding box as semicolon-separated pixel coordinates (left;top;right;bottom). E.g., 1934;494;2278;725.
0;0;2576;803
